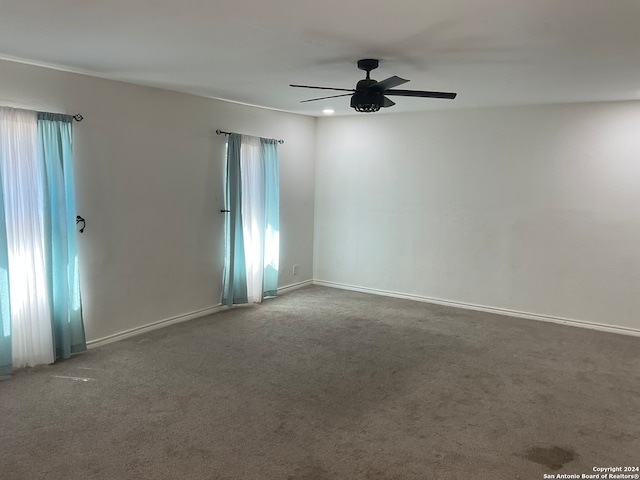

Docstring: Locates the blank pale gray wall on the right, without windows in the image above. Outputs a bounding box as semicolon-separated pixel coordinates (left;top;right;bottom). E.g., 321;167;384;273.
314;102;640;331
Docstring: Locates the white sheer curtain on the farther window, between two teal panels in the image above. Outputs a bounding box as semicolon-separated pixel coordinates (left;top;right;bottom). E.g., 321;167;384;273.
240;135;265;303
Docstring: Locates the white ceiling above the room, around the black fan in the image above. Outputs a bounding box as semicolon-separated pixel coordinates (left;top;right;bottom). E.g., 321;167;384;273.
0;0;640;115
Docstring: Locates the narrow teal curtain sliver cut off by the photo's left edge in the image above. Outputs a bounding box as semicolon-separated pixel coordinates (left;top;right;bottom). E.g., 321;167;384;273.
0;171;12;377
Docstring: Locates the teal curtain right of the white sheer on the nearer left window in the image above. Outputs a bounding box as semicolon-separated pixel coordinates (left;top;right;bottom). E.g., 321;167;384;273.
38;113;87;358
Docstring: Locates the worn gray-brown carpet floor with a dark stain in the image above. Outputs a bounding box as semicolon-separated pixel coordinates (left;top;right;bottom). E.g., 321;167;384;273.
0;286;640;480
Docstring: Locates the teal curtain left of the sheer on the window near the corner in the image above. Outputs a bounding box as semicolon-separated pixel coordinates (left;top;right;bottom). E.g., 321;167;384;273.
222;133;247;306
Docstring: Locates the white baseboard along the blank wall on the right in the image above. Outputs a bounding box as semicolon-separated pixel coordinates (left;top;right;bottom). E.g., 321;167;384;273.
313;280;640;337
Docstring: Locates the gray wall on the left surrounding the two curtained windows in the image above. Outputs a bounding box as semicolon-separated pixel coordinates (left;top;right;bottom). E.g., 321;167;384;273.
0;61;315;340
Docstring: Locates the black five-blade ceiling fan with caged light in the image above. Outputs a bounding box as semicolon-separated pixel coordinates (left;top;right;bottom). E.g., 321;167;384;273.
290;58;457;112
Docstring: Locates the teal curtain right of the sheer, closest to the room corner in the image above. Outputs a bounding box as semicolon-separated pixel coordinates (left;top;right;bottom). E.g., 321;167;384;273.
260;138;280;297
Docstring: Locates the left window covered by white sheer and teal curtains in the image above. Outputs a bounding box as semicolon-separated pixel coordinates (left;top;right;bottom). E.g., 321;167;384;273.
0;107;86;375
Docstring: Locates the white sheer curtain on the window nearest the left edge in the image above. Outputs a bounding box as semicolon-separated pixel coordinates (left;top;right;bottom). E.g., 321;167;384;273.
0;107;54;368
